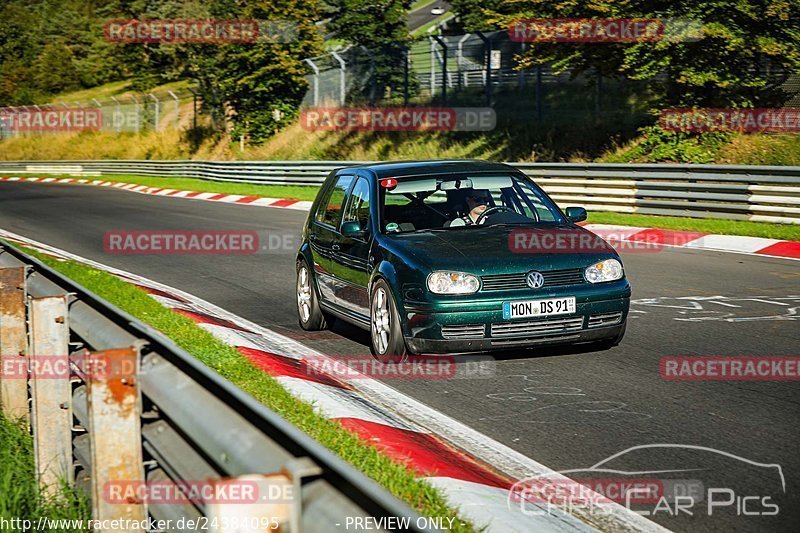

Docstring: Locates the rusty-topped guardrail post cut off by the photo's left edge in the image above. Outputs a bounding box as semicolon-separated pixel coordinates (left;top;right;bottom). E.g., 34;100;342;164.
0;267;28;423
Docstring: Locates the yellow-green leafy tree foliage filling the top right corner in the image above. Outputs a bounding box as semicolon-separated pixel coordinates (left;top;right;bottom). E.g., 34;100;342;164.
454;0;800;107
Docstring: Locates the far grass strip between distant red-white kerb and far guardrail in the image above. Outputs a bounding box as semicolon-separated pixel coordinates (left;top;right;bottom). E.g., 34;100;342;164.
20;175;800;241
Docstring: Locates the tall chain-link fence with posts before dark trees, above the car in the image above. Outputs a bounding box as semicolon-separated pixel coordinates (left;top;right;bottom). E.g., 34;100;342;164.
303;31;800;120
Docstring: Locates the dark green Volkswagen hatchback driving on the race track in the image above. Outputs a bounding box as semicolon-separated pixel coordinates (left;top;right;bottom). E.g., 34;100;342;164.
297;161;631;362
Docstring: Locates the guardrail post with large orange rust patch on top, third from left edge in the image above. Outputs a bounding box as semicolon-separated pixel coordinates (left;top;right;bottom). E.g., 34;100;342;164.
86;346;147;532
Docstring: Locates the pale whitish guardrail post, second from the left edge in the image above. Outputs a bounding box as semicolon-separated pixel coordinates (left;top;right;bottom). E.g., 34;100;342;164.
29;295;73;497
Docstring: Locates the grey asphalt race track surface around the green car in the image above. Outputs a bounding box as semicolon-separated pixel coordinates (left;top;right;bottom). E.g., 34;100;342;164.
0;183;800;531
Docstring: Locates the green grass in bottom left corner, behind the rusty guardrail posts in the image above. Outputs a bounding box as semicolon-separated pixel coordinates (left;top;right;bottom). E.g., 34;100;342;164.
0;416;91;532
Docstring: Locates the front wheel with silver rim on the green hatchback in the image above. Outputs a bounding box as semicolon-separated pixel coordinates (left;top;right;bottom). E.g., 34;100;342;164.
369;279;408;363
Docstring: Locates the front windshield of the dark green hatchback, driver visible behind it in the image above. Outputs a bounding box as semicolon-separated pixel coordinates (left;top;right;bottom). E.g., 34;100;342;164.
380;174;565;233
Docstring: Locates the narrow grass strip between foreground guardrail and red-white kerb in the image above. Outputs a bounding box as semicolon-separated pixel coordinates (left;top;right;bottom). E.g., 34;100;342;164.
17;248;473;531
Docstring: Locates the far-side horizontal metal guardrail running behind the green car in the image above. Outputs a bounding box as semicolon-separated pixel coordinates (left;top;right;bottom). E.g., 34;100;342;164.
0;161;800;224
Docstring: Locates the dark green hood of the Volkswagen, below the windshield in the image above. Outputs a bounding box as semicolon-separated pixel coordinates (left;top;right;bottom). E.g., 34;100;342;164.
392;226;617;275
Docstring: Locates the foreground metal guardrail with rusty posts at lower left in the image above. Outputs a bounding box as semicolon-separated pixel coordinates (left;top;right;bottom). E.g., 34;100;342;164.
0;241;432;533
